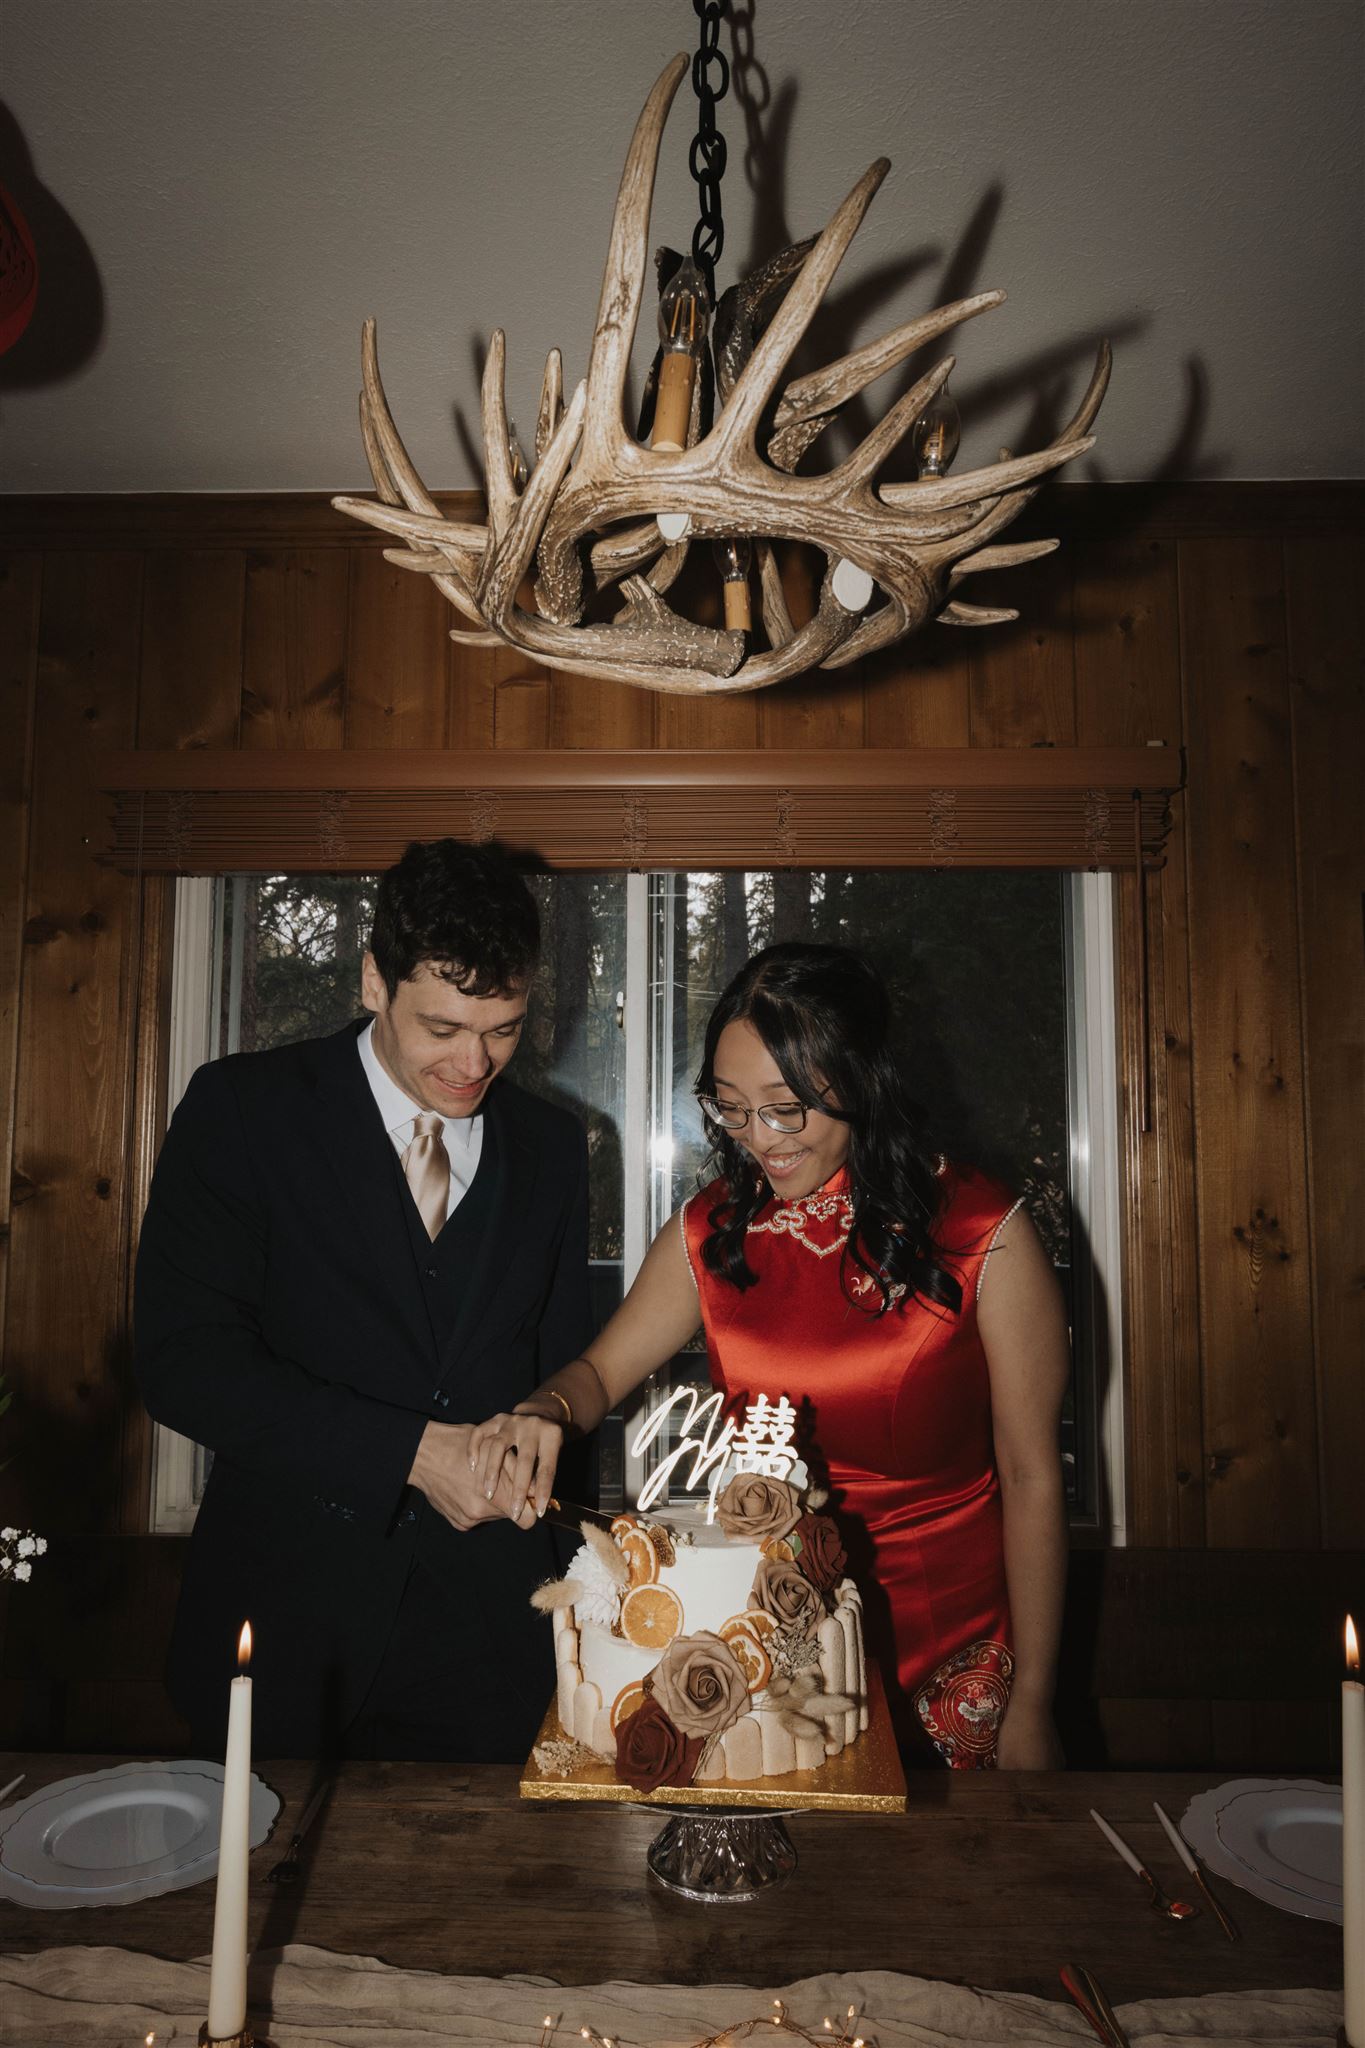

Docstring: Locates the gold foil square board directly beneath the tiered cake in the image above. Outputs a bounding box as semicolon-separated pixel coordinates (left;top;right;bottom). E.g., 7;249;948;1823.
520;1663;907;1812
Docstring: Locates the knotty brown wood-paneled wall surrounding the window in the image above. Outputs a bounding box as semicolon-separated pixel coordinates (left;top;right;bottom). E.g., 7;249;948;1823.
0;485;1365;1550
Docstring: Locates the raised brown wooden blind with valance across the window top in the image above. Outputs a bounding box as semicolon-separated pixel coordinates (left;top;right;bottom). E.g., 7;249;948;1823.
100;748;1179;874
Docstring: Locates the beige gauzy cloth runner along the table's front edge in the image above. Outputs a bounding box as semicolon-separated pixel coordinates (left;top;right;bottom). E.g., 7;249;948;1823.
0;1944;1340;2048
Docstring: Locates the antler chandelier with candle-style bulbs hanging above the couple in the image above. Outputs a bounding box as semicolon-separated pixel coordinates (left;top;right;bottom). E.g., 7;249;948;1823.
334;32;1109;696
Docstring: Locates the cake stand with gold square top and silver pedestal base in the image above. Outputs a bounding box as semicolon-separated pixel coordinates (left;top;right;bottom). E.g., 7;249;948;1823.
520;1665;905;1907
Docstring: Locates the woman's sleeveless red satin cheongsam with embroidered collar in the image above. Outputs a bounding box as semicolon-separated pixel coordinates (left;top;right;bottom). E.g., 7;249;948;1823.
681;1167;1019;1769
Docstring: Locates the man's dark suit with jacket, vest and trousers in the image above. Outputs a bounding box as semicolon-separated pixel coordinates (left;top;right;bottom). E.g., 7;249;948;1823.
135;1026;591;1755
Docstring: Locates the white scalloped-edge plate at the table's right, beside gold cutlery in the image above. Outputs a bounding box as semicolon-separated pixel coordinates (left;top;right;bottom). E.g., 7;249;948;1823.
1181;1778;1340;1925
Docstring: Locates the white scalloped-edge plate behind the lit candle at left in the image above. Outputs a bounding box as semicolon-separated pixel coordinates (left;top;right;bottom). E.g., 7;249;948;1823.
0;1761;280;1911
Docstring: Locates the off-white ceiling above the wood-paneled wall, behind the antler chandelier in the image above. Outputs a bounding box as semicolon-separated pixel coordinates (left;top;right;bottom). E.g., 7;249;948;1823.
0;0;1365;492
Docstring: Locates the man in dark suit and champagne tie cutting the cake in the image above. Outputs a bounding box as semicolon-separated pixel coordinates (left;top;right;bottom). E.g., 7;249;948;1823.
137;840;591;1763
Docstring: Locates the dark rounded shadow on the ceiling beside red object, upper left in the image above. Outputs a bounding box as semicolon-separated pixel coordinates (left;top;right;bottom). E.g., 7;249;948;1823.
0;102;104;391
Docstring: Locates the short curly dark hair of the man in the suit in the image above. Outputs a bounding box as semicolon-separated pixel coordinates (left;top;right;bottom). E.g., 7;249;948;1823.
370;840;540;999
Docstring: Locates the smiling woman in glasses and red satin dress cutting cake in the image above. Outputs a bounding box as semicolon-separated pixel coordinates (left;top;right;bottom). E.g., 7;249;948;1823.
471;944;1066;1769
